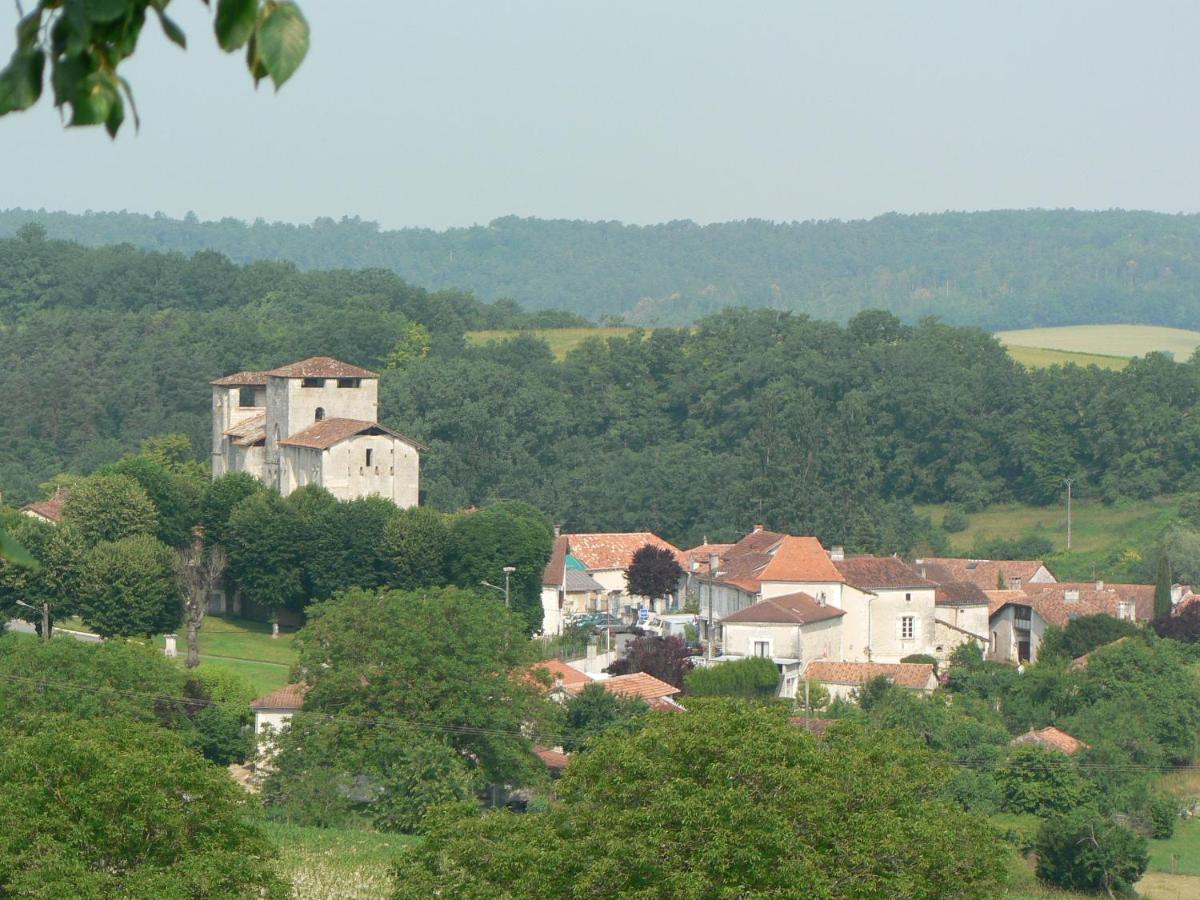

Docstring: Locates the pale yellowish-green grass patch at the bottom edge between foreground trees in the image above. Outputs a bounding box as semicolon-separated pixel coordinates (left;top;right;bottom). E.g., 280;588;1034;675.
266;822;416;900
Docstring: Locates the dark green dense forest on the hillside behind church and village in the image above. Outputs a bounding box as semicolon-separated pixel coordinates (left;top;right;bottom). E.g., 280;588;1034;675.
0;228;1200;561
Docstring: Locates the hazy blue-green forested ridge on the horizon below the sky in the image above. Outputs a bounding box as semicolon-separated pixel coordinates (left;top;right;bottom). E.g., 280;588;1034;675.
7;210;1200;330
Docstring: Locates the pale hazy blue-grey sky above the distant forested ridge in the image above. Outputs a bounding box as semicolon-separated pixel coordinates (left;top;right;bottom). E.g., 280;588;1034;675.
0;0;1200;228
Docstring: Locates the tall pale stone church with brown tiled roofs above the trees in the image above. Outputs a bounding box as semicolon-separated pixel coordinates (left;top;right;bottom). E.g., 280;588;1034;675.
211;356;424;508
